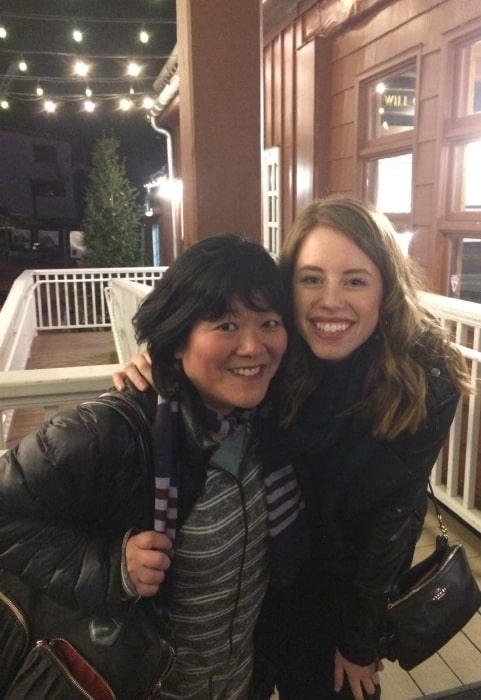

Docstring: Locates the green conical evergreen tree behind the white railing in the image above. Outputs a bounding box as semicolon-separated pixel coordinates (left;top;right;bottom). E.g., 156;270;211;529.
82;134;142;267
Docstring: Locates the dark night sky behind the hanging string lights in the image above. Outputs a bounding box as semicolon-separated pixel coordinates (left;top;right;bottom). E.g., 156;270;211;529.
0;0;176;189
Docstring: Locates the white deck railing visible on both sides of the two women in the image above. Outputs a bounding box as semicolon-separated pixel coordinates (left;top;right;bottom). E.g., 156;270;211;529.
0;268;481;532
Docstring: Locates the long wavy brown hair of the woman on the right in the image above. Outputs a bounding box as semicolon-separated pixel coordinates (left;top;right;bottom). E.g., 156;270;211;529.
280;196;469;439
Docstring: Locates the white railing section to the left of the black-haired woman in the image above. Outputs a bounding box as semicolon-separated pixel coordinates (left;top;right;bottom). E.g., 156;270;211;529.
0;267;165;447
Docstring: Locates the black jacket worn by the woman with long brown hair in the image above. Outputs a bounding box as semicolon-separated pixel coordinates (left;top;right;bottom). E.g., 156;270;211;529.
298;364;459;665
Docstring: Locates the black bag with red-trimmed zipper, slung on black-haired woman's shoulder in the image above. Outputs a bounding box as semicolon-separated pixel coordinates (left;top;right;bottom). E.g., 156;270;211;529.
0;394;175;700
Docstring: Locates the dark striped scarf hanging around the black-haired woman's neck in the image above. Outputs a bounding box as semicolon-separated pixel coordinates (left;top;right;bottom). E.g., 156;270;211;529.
152;382;308;587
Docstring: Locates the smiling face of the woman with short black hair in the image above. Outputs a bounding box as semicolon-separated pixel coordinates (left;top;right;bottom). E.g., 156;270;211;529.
176;303;287;415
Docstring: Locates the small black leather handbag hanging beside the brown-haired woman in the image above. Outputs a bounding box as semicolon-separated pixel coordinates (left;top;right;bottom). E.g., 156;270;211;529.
381;489;481;671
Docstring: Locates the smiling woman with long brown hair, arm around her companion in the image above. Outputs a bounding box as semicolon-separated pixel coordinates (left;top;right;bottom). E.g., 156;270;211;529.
118;196;468;700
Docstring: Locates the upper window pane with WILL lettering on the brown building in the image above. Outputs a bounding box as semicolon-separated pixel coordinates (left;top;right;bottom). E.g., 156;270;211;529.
367;67;416;139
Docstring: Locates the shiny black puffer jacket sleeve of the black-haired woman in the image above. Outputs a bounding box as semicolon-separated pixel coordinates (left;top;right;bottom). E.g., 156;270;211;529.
0;392;156;614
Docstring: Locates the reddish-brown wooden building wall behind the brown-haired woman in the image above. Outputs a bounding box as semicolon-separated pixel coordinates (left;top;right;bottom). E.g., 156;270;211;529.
264;0;481;293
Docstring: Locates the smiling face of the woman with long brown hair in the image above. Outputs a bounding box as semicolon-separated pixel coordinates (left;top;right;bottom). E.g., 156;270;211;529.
293;226;383;360
